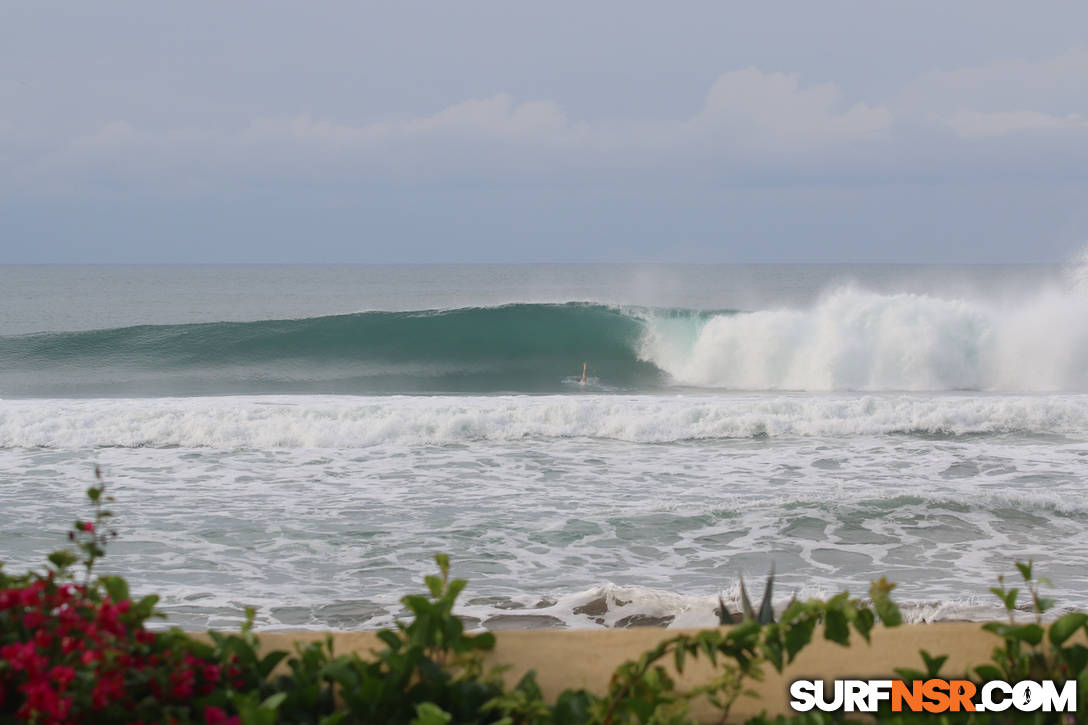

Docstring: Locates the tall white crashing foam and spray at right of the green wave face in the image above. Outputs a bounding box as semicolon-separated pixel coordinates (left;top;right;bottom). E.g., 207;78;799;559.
640;274;1088;391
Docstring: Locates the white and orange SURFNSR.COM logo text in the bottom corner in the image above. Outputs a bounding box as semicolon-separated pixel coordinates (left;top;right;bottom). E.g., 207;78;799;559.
790;678;1077;713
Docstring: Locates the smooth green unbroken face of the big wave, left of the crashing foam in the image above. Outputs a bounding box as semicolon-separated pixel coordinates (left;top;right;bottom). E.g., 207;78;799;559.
0;303;664;395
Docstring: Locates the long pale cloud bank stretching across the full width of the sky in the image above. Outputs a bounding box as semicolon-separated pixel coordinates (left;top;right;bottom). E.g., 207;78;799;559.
6;48;1088;194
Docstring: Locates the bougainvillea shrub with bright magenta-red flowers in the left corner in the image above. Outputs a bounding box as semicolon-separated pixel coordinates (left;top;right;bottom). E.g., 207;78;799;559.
0;471;249;723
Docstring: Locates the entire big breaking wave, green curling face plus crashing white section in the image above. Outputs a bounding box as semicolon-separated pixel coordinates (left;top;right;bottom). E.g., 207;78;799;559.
6;270;1088;396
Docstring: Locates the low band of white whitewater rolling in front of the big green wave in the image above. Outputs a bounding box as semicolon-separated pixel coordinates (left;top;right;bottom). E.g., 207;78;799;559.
0;394;1088;450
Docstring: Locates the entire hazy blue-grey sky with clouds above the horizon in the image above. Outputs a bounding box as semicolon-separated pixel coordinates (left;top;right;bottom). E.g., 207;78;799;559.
0;0;1088;263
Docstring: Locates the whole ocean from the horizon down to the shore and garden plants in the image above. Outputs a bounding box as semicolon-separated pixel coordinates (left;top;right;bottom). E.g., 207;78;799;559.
0;265;1088;629
